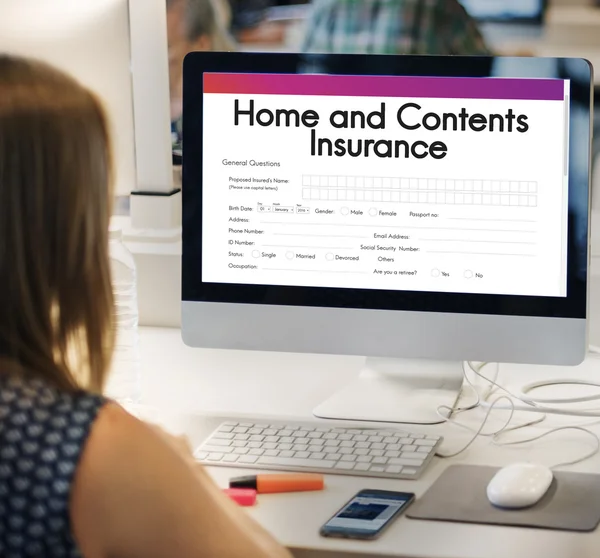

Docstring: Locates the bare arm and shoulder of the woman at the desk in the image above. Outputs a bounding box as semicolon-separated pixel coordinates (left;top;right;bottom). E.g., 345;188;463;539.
71;404;291;558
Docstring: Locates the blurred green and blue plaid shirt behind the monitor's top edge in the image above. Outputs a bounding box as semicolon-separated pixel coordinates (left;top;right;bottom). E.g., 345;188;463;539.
303;0;491;55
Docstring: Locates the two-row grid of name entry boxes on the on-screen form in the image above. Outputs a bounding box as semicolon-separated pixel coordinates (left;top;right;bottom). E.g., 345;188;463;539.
302;175;538;207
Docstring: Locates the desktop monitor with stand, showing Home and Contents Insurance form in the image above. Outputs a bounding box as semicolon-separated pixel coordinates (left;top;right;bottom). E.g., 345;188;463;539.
182;53;592;423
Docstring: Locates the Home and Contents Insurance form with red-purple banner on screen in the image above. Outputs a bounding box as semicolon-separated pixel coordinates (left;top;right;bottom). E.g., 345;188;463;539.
202;73;569;297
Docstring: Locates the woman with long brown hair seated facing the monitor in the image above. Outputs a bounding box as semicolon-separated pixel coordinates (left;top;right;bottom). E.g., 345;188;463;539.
0;56;289;558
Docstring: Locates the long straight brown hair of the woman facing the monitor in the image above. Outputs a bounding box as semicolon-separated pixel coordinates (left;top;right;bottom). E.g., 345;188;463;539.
0;55;114;391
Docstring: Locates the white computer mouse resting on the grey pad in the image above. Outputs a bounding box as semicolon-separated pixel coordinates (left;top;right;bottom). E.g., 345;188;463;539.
487;463;554;509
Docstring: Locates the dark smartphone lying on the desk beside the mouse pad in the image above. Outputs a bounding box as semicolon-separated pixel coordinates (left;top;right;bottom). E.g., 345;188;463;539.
320;490;415;540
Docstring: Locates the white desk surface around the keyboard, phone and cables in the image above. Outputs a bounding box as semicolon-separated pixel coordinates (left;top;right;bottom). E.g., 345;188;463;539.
141;328;600;558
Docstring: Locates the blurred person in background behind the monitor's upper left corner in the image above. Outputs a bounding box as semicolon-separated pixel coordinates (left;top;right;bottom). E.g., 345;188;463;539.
167;0;236;151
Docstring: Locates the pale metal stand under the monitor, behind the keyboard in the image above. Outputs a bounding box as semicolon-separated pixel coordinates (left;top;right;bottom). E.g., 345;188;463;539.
313;357;463;424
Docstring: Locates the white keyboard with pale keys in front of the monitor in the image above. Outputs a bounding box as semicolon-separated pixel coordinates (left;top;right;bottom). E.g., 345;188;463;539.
194;421;442;480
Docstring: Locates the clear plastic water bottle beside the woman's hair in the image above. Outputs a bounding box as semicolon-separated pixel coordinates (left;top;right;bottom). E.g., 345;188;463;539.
106;227;142;405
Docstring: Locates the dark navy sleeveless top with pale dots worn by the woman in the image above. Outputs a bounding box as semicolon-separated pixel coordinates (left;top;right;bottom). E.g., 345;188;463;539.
0;374;104;558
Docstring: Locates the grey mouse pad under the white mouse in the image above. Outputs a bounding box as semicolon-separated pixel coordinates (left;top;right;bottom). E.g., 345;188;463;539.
406;465;600;532
